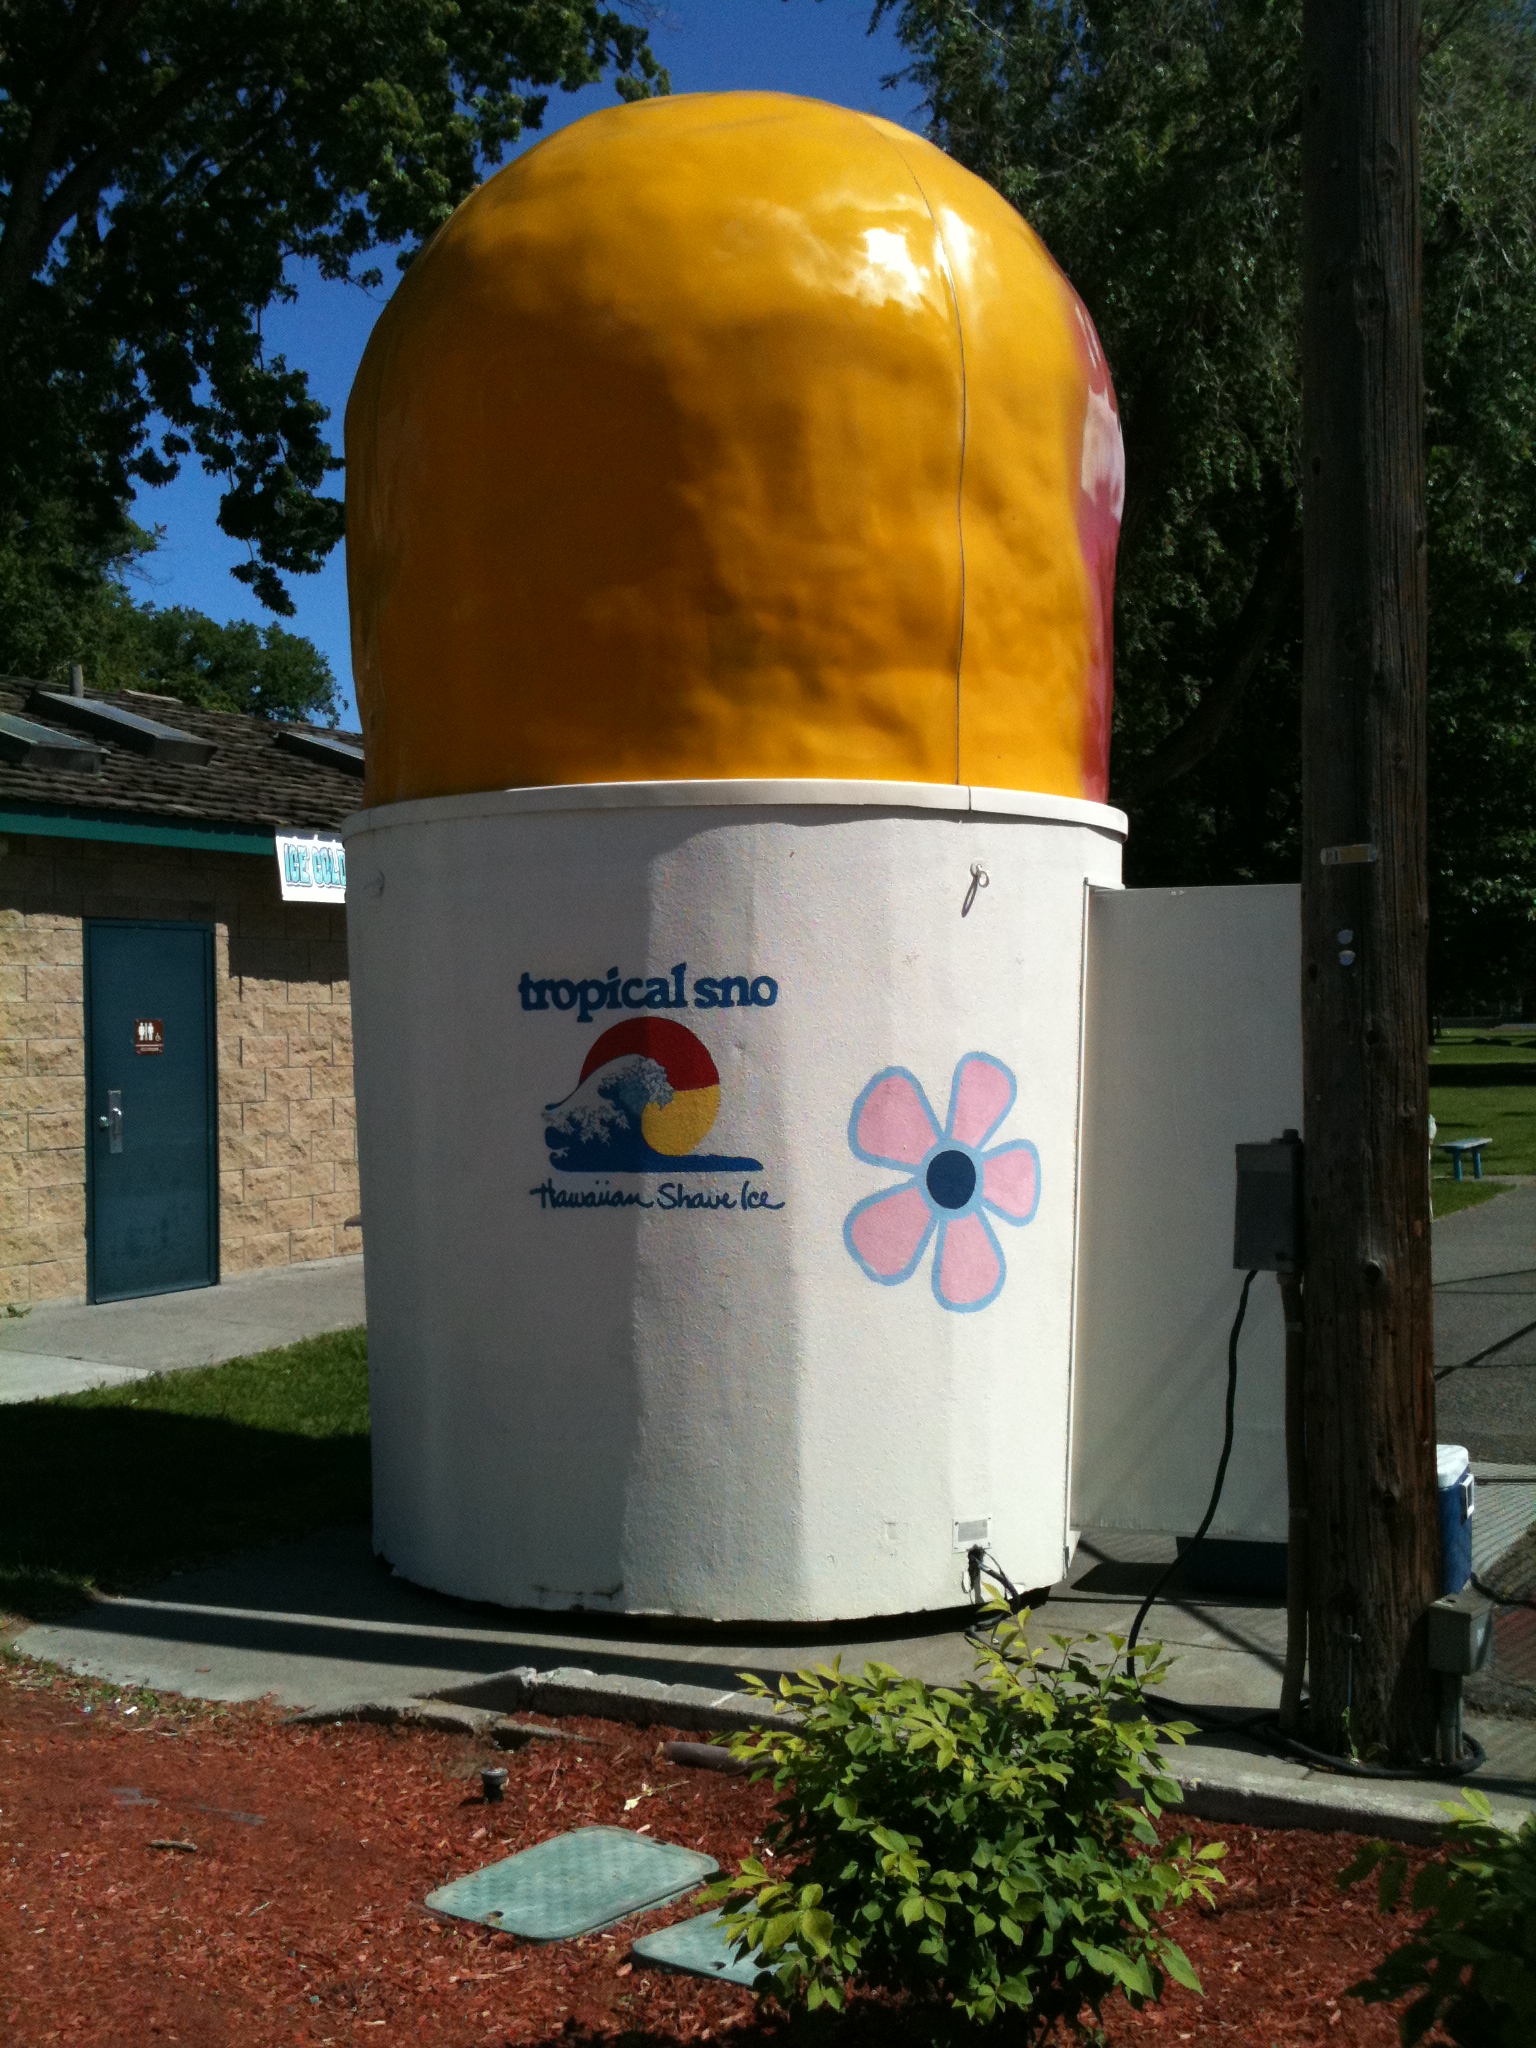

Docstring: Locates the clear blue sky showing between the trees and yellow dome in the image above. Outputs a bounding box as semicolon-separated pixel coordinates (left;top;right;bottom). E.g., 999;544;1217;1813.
135;0;920;725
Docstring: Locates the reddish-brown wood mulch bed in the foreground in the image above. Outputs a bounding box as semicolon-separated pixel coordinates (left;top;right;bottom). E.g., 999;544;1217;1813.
0;1665;1433;2048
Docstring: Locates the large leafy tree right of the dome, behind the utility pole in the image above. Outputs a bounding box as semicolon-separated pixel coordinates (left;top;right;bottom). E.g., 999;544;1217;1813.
877;0;1536;1006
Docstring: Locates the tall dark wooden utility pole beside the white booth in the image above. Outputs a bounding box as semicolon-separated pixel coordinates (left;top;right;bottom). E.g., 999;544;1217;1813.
1303;0;1440;1761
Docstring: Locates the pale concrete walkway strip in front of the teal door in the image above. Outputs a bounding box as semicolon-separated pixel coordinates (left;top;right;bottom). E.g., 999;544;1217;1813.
0;1255;362;1405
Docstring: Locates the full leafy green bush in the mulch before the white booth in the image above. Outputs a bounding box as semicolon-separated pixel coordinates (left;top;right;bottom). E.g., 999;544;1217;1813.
711;1608;1225;2030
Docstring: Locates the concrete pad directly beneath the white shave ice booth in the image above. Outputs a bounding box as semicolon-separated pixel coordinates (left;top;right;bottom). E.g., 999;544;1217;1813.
18;1507;1536;1712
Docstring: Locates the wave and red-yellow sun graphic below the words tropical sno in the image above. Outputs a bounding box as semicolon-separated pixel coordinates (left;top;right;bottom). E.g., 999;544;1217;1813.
545;1016;762;1174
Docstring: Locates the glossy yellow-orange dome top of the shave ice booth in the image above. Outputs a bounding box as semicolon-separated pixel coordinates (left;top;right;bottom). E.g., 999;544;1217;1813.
346;92;1124;803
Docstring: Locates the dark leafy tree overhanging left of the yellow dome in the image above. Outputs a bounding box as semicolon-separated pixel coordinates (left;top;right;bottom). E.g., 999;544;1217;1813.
0;0;668;612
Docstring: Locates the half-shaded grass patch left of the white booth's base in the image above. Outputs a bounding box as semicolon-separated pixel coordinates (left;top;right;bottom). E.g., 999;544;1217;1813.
0;1329;371;1620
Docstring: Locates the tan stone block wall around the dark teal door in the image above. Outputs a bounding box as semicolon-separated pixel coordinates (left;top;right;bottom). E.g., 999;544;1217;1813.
0;836;362;1305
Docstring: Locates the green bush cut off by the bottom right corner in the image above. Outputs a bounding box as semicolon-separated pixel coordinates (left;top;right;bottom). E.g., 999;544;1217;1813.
1339;1792;1536;2048
